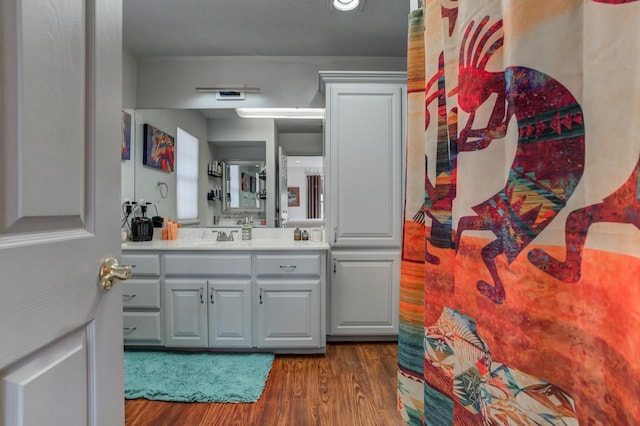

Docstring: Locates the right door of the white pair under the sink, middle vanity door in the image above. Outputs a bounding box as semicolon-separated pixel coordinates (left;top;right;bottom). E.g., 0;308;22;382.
207;280;252;348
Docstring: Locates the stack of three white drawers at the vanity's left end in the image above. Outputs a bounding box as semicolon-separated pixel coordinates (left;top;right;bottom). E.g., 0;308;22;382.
122;254;164;346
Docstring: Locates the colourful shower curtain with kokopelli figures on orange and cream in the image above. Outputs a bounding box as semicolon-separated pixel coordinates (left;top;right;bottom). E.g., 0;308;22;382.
398;0;640;425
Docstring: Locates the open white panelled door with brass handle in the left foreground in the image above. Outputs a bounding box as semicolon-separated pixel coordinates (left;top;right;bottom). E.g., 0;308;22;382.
0;0;124;426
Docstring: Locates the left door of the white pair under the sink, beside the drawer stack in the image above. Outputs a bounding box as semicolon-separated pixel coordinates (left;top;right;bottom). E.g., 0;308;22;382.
164;279;208;348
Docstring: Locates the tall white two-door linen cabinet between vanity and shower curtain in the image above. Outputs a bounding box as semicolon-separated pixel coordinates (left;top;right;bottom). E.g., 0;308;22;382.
320;71;407;340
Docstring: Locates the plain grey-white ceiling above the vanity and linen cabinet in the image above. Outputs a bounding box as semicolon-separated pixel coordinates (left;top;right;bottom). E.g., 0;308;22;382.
123;0;410;133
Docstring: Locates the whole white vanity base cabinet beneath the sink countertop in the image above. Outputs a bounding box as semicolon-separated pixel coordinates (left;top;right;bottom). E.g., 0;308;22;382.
123;246;327;353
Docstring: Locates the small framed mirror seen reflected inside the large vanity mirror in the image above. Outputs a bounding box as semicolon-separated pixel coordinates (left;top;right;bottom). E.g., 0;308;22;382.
222;160;267;213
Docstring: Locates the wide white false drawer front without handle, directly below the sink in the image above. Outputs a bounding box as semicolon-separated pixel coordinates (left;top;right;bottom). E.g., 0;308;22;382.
164;254;251;277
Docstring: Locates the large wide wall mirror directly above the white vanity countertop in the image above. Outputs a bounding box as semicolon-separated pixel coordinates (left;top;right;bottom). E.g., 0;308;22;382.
121;109;324;227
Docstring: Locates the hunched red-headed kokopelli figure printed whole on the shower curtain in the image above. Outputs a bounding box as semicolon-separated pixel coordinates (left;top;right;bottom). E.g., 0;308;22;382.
455;17;585;303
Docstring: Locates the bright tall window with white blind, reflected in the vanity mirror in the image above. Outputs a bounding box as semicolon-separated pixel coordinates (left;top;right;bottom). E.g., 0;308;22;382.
176;127;198;221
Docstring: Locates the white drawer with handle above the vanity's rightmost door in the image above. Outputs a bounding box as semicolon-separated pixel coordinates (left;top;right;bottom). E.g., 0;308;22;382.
256;254;321;277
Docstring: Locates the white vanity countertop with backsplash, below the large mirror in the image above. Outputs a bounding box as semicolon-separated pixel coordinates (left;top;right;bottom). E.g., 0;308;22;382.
122;228;329;251
